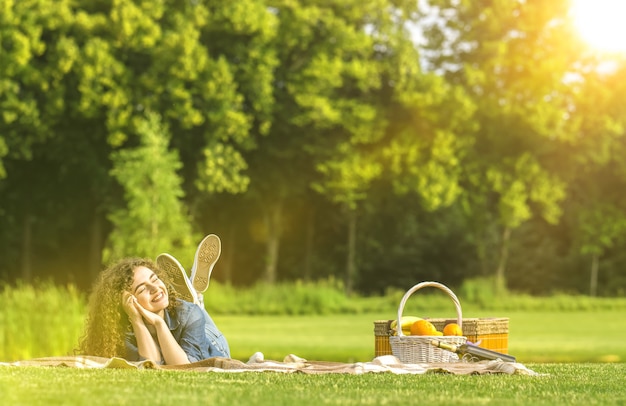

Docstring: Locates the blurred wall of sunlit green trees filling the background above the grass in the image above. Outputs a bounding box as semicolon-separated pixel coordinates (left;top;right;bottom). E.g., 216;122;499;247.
0;0;626;298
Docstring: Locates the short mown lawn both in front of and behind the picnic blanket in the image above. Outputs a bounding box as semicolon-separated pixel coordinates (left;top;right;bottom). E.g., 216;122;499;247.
0;311;626;406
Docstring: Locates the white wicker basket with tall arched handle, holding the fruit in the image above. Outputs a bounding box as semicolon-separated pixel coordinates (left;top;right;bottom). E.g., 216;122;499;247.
389;282;467;364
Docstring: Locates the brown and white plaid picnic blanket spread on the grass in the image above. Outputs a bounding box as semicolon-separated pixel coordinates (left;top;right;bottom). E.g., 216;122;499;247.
0;352;538;375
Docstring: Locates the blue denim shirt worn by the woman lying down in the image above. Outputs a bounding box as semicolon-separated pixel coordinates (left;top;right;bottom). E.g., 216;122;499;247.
125;300;230;362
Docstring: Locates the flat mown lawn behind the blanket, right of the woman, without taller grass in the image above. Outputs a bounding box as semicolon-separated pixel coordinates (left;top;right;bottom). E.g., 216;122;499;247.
214;311;626;363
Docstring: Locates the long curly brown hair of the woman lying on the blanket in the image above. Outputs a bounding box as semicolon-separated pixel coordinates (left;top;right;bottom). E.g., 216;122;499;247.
77;258;179;358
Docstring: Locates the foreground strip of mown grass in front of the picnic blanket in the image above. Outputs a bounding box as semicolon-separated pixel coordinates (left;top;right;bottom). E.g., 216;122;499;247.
0;363;626;406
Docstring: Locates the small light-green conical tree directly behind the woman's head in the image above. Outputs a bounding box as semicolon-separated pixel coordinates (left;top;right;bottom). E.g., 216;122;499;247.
105;112;198;261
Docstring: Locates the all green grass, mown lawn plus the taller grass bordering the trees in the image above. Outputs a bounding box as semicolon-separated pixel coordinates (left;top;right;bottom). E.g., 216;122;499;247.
0;285;626;405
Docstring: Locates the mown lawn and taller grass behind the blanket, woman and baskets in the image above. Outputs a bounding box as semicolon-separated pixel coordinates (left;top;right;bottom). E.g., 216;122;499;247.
0;282;626;362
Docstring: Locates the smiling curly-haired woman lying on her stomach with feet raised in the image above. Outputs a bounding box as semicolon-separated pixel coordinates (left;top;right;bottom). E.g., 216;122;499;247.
79;234;230;365
